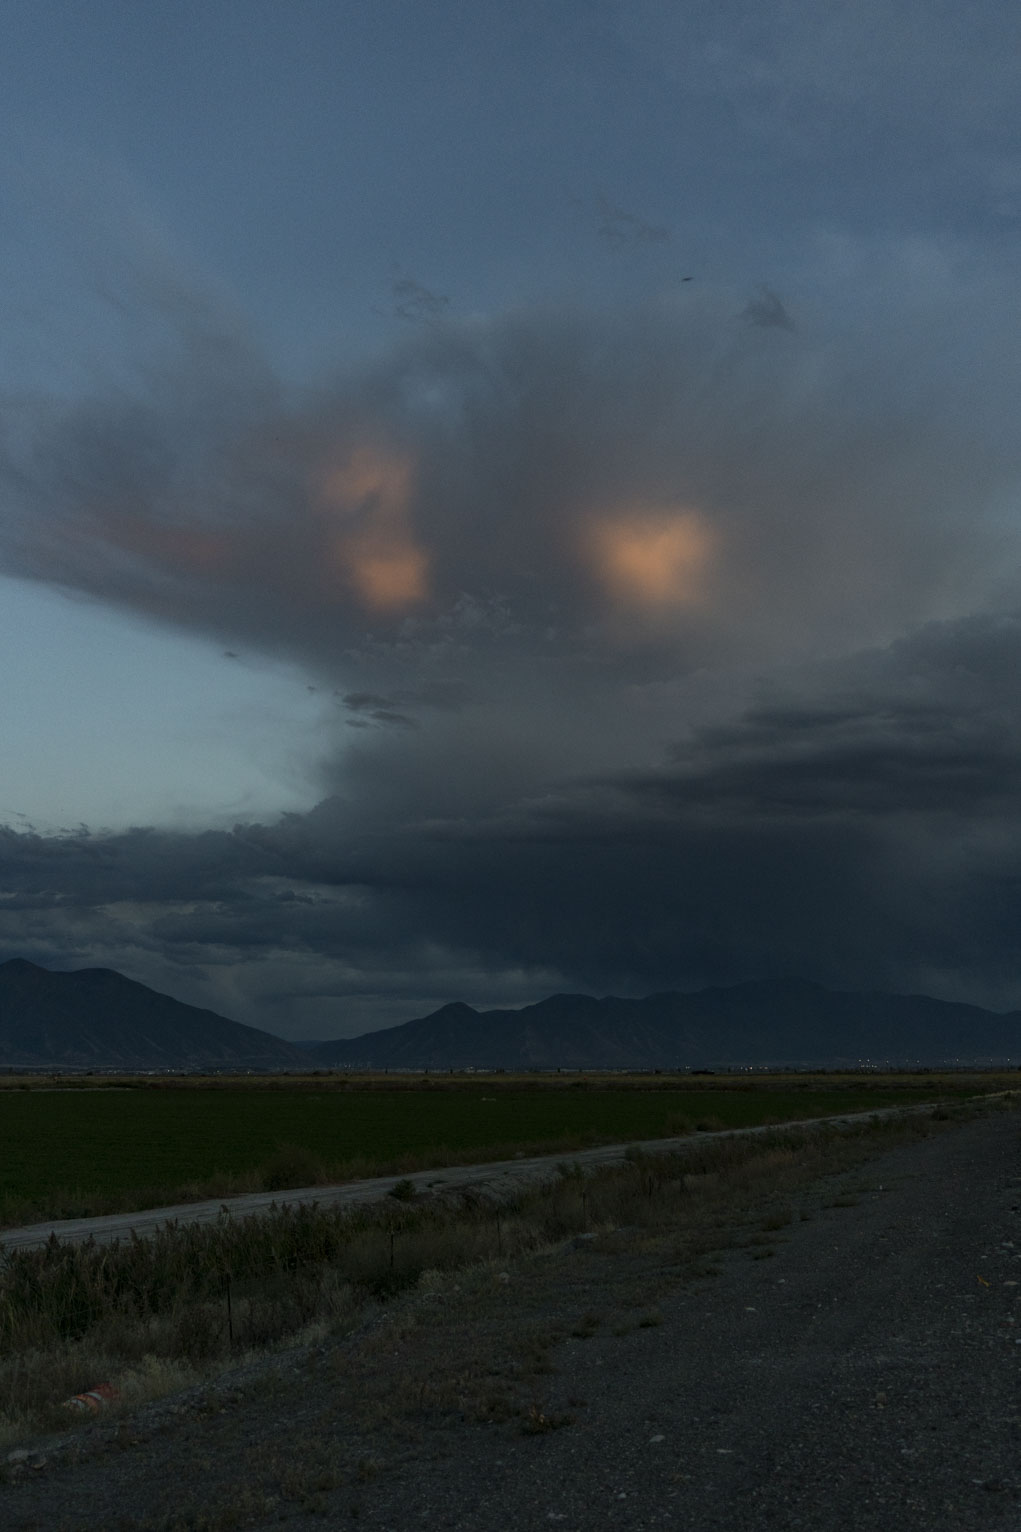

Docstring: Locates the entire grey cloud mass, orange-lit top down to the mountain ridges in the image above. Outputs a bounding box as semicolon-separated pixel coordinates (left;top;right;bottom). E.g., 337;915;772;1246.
0;265;1021;1036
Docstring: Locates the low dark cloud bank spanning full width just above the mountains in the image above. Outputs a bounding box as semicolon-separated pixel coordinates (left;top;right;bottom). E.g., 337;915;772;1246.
0;616;1021;1034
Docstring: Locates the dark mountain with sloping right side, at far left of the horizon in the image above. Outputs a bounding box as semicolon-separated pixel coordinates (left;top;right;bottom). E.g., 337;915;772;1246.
0;958;308;1069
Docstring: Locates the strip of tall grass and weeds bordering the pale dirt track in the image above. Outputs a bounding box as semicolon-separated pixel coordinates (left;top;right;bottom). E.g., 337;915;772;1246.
0;1118;981;1442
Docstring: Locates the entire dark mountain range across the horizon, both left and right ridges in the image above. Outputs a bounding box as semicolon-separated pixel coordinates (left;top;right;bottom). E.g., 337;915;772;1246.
0;958;1021;1071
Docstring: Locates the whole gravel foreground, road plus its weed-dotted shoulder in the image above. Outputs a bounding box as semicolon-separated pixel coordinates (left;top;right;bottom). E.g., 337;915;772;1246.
0;1114;1021;1532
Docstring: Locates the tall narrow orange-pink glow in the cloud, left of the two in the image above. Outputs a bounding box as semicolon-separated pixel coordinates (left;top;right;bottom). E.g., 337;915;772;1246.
317;446;429;611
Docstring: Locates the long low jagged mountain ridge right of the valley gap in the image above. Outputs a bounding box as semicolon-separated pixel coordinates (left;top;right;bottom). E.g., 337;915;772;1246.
308;979;1021;1069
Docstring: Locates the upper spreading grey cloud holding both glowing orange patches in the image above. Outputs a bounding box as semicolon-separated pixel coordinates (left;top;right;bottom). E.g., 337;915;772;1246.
0;270;1016;870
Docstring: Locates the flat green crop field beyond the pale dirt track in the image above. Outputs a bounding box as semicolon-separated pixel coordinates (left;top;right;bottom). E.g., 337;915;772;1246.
0;1085;938;1224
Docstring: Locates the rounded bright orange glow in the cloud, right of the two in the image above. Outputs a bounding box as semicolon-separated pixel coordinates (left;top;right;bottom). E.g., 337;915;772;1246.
590;510;713;608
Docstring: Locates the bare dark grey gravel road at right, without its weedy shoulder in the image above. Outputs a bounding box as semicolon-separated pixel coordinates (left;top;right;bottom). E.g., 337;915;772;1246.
426;1118;1021;1532
